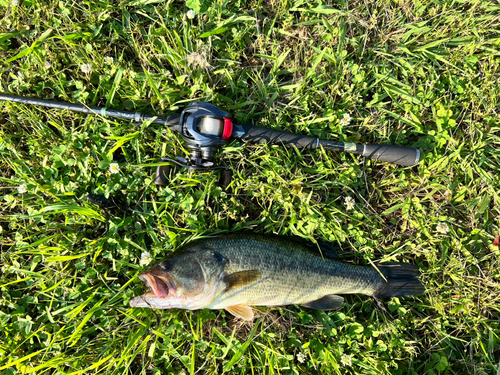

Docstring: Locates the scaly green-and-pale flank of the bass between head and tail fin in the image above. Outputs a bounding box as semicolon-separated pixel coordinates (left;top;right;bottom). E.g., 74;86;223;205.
206;236;385;309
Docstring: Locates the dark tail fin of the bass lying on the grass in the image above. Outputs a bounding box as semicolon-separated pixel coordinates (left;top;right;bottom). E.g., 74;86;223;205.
373;263;425;298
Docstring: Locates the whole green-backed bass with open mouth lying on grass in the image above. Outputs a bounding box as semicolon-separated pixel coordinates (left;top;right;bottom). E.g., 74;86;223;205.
130;232;425;320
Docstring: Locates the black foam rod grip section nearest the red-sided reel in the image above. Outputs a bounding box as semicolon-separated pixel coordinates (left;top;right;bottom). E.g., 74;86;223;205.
241;125;318;149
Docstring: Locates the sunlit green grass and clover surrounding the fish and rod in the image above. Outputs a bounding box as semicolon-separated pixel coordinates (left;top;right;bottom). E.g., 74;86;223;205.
0;0;500;375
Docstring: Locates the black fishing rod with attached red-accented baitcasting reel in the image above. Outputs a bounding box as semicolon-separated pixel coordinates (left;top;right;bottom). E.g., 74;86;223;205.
0;94;420;187
